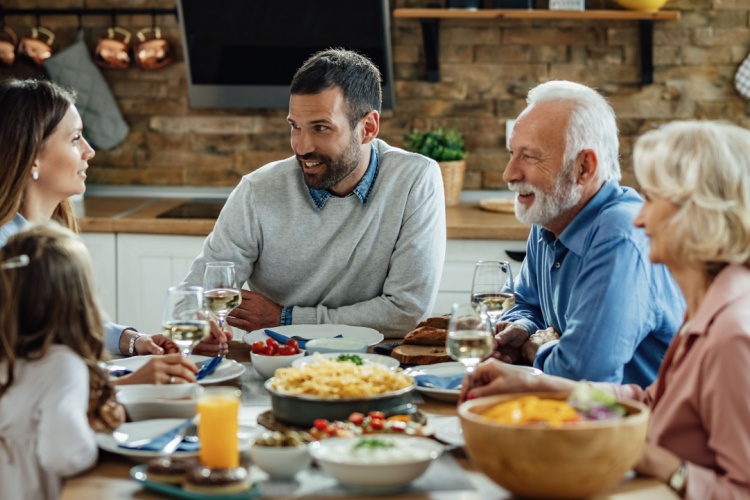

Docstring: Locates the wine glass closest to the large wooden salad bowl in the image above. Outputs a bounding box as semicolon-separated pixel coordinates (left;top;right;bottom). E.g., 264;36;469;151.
446;304;493;389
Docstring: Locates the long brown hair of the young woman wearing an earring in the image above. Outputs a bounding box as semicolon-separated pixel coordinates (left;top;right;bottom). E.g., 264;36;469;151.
0;79;78;232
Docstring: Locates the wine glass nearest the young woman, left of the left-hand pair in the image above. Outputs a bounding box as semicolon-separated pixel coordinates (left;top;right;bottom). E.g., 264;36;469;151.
162;285;211;357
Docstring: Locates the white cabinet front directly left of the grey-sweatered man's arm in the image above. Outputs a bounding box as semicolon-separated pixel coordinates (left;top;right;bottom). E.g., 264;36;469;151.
117;233;205;333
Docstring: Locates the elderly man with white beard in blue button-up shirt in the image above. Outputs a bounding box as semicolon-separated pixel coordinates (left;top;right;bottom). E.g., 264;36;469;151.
495;81;685;387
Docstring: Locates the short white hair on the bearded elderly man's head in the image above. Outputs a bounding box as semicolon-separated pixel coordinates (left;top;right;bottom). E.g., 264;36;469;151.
519;80;622;181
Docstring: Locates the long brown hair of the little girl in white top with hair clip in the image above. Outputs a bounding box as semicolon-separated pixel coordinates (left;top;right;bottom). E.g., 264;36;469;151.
0;222;103;397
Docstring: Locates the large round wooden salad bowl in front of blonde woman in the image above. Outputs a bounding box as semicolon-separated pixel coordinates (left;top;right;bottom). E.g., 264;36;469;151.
458;393;650;498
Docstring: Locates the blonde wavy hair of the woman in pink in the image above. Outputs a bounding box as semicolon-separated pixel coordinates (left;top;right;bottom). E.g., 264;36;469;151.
633;121;750;270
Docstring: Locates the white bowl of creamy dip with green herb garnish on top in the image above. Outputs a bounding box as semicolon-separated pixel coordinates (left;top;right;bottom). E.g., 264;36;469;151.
309;435;443;490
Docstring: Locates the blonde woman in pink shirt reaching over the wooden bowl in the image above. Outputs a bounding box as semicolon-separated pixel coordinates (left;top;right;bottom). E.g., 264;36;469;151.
462;121;750;500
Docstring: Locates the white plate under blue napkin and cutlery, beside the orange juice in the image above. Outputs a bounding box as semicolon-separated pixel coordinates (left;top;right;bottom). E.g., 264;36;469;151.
96;418;263;459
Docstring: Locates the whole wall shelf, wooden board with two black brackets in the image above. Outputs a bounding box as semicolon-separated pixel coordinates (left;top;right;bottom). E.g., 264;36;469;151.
393;9;680;84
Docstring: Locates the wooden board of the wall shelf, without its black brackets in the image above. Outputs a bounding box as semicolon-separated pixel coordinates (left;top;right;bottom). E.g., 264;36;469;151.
393;9;680;21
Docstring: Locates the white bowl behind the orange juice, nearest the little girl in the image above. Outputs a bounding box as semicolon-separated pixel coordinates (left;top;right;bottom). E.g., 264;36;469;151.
115;384;200;422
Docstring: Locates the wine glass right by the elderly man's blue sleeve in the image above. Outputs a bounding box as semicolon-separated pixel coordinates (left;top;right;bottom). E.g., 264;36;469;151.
471;260;516;330
